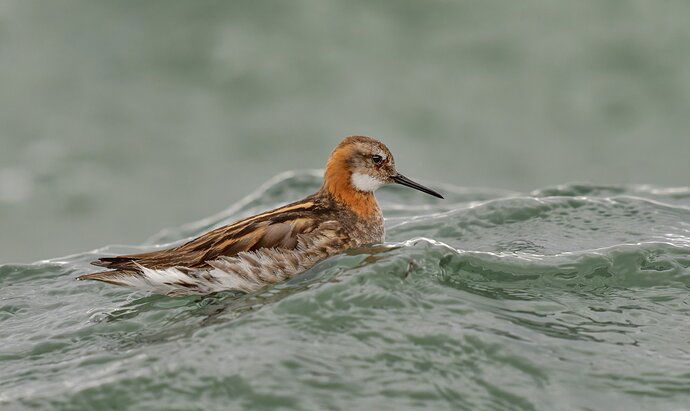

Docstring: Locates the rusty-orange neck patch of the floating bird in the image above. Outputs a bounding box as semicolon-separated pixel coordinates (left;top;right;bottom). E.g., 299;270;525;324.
321;158;381;219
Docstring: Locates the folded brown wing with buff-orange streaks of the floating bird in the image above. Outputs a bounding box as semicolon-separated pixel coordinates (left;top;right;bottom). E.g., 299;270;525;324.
79;201;339;279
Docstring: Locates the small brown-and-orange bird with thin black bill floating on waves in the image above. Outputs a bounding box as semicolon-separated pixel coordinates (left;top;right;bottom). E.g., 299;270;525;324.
77;136;443;296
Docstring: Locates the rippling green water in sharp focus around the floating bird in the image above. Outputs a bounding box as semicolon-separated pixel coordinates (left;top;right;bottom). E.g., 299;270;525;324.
0;172;690;410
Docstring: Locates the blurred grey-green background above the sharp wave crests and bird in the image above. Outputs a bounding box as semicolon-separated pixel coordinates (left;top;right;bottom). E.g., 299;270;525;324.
0;0;690;262
